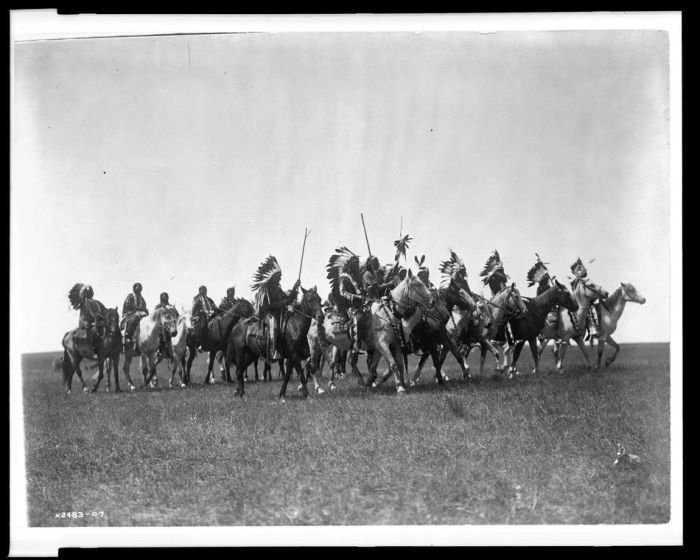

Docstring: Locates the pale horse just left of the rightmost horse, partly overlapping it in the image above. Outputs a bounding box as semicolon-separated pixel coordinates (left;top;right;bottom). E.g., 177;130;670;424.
538;281;608;373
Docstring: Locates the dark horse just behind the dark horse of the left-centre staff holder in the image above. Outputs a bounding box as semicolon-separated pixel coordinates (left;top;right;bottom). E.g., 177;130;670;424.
185;298;255;385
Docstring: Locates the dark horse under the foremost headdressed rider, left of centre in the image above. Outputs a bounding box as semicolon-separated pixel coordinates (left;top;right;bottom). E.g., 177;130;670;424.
226;286;321;402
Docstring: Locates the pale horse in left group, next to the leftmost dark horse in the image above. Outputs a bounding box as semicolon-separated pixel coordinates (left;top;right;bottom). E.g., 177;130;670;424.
115;307;178;391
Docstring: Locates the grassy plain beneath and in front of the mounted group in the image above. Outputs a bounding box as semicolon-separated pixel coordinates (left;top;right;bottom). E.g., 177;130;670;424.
22;344;670;527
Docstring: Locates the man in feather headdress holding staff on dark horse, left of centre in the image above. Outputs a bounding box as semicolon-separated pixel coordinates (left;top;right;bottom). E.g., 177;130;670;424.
251;255;301;360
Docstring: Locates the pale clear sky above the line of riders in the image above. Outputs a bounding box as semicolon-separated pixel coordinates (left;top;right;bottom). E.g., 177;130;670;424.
11;25;672;352
